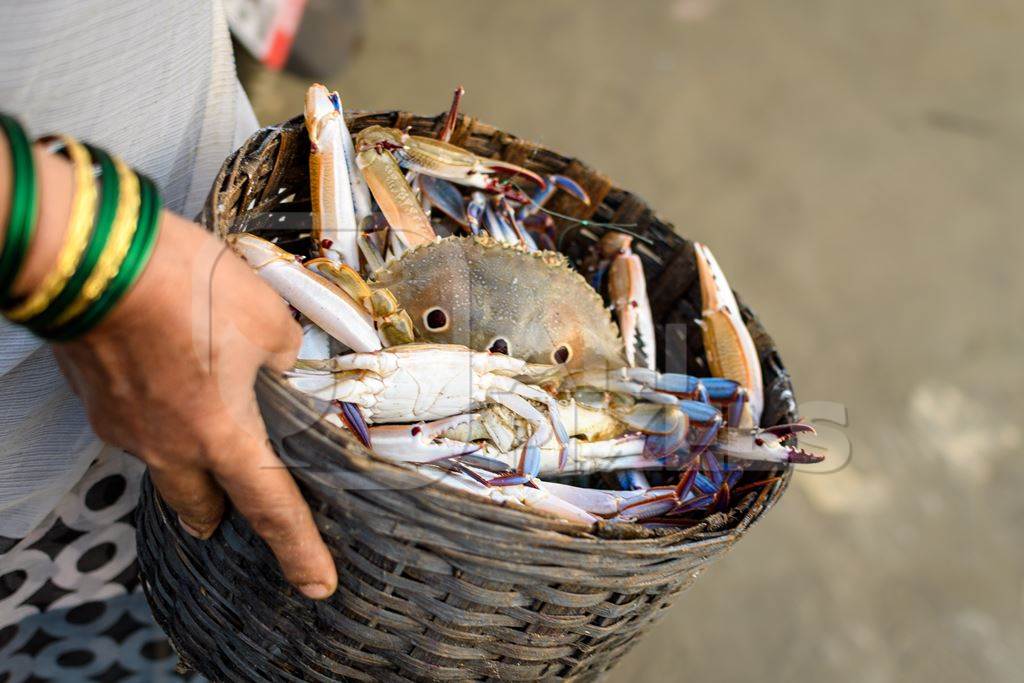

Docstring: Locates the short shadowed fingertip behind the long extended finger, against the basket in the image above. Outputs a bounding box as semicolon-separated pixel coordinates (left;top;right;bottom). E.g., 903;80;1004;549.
150;465;224;540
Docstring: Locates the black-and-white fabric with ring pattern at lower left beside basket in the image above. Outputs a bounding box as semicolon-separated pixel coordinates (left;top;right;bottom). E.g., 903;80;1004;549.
0;447;203;683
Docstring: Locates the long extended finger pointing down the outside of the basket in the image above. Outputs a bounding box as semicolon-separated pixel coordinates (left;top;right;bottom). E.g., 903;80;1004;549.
212;430;338;600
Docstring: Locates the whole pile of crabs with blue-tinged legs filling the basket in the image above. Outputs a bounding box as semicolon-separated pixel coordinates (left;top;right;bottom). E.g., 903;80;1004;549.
228;85;820;525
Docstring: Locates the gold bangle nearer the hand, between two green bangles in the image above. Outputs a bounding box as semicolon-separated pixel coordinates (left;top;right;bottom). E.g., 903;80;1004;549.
53;157;139;327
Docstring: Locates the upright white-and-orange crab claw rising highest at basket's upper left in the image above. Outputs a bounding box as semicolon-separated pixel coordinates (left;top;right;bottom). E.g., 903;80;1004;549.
305;83;359;268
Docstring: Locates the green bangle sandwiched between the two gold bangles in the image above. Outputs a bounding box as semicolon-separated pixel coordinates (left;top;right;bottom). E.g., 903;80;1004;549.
23;144;120;337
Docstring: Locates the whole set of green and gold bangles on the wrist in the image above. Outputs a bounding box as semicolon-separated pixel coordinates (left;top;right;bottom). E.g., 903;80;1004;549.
0;114;161;341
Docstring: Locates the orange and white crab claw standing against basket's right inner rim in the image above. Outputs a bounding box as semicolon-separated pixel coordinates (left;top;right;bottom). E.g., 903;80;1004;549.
693;242;764;427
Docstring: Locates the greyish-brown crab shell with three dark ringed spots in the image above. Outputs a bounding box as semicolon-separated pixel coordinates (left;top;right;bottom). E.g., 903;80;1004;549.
370;237;625;371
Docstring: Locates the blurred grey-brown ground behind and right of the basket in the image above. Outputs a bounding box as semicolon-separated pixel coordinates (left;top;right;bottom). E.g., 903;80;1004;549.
239;0;1024;683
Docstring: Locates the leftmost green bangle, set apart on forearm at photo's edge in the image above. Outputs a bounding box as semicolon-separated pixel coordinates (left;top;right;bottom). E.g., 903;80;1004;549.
0;114;39;308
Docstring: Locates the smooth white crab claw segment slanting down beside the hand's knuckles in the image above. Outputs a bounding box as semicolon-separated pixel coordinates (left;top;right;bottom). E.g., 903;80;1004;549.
226;232;381;351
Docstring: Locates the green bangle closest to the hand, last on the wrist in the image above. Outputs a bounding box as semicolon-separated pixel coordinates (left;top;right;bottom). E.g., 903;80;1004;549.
47;175;163;341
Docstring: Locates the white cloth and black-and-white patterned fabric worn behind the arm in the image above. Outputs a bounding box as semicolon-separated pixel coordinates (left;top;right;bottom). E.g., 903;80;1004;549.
0;0;256;683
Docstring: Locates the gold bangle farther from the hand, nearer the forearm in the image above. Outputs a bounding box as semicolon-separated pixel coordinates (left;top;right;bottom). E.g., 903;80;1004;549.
4;135;98;323
